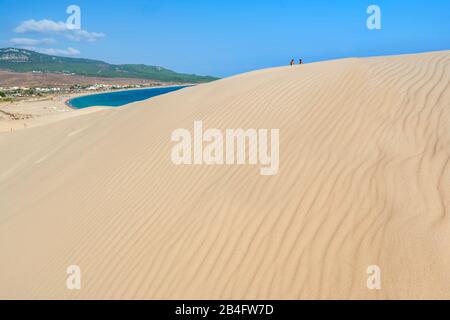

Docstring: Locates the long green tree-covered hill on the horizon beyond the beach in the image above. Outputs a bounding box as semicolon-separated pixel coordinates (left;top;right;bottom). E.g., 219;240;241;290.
0;48;217;83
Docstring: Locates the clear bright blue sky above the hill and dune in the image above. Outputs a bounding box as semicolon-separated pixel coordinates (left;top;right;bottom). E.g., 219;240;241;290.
0;0;450;76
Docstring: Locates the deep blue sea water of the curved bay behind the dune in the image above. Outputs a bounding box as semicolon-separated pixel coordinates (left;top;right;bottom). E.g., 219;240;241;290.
67;86;186;109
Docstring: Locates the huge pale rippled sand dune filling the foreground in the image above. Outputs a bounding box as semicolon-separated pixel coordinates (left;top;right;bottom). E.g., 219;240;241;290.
0;51;450;299
